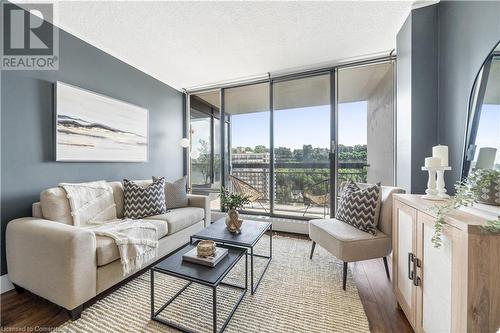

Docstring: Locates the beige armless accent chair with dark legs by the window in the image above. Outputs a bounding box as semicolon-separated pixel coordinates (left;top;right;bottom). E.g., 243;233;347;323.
309;184;405;290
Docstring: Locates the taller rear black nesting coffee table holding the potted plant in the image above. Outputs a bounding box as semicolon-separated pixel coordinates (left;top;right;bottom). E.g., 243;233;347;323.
191;218;273;295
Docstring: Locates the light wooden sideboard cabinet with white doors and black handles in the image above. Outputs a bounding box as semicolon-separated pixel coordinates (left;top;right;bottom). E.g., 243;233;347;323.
392;194;500;333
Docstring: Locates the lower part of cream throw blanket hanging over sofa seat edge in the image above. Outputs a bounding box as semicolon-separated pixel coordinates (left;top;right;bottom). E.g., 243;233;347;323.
89;219;158;275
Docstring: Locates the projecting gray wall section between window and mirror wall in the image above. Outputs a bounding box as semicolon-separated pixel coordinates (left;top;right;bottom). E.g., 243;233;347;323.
396;6;438;193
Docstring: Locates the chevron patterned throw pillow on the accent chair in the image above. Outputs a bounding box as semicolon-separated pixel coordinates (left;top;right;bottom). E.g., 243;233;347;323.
336;181;380;235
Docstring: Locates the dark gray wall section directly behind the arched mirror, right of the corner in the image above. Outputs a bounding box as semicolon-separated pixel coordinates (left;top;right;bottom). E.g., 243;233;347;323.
438;1;500;185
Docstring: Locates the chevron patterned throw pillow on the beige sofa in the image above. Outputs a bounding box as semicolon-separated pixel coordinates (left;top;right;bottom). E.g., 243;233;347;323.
123;178;167;219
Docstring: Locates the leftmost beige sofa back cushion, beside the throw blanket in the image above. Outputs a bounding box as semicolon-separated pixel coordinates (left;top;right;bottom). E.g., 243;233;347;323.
40;187;73;225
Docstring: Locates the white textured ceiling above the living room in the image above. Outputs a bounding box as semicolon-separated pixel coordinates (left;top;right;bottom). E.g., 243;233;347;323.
47;1;413;89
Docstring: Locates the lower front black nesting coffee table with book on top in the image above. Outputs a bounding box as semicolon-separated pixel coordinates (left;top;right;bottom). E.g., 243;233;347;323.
151;244;248;333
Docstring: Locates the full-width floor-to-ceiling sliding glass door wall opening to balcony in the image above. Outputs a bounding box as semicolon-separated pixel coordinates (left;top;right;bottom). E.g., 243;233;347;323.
189;61;395;219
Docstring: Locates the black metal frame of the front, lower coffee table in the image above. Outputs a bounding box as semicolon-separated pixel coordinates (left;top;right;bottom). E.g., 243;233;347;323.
151;249;248;333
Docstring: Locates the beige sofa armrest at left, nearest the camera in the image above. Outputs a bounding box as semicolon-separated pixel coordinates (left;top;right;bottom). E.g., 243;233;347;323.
6;217;97;310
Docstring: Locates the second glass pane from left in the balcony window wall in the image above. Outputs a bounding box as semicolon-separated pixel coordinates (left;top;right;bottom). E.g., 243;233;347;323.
224;83;271;214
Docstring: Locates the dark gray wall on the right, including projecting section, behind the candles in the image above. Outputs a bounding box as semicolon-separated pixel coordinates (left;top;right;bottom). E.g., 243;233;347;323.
397;1;500;193
